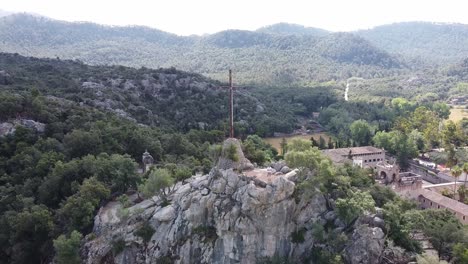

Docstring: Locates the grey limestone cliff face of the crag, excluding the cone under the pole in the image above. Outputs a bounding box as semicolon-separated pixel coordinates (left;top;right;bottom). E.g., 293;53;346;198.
82;168;327;264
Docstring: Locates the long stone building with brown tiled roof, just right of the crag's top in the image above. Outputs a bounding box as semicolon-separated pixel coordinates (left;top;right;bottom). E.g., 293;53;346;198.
322;146;385;169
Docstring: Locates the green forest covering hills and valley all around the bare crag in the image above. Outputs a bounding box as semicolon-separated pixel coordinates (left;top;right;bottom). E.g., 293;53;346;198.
0;11;468;263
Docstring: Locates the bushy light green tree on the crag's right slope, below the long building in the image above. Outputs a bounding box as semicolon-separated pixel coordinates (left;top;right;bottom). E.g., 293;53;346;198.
336;190;375;225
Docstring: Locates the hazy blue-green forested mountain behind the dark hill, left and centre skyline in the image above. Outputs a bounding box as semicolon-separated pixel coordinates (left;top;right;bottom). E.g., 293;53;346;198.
0;14;405;86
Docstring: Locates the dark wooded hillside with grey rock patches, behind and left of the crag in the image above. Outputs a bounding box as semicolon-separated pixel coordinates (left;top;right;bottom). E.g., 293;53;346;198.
0;53;344;263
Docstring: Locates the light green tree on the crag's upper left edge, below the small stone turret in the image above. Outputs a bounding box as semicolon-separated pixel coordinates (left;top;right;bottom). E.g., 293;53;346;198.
138;169;174;198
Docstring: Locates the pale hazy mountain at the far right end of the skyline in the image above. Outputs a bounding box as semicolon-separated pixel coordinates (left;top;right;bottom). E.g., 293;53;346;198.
355;22;468;62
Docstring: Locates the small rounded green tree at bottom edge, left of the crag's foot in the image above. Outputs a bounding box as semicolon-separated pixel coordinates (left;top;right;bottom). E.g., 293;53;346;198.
54;230;83;264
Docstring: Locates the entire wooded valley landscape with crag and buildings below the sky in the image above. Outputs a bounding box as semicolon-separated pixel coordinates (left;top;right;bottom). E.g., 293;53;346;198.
0;9;468;264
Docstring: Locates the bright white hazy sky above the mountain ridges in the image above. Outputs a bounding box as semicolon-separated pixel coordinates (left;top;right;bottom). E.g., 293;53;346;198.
0;0;468;35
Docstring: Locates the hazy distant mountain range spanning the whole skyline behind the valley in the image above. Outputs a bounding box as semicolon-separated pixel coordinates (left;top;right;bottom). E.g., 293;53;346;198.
4;14;468;85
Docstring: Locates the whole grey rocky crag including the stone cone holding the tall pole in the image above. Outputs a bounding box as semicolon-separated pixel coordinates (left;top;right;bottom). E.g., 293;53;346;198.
81;139;392;264
